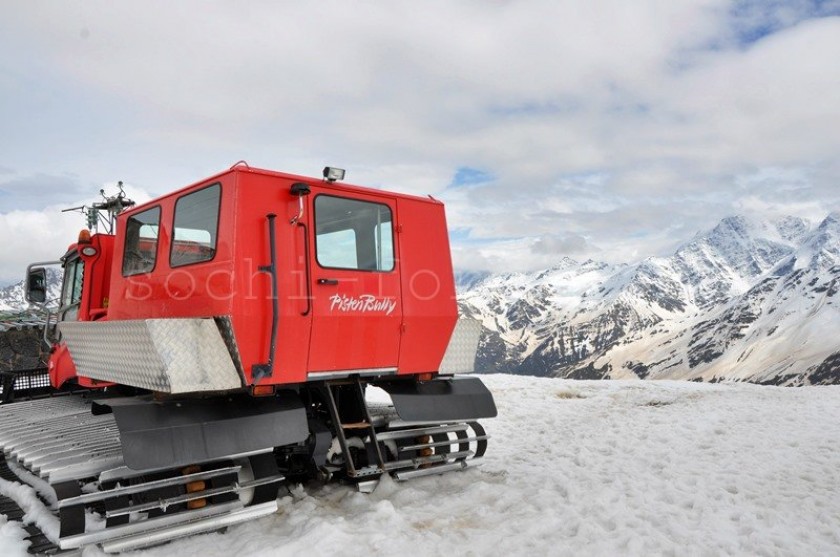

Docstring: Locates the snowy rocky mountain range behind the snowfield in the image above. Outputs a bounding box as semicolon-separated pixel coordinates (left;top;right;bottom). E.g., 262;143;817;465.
459;213;840;385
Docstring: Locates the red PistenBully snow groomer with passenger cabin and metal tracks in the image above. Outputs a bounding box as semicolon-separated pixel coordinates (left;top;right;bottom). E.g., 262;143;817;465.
0;163;496;552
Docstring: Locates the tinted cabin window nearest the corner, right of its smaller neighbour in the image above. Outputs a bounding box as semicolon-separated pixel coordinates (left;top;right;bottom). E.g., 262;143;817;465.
169;184;222;267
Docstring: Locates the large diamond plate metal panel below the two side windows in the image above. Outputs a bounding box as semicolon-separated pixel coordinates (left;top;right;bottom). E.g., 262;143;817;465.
59;319;242;394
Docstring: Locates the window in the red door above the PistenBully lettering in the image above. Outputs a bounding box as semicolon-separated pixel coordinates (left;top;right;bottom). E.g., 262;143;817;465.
315;195;394;271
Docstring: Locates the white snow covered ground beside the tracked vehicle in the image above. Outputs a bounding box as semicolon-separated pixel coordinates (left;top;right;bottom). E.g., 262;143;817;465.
0;375;840;557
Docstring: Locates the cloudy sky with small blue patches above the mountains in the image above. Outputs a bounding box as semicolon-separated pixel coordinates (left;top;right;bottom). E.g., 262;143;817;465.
0;0;840;285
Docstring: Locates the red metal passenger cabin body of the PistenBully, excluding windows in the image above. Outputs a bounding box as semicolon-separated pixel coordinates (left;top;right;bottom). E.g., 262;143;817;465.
72;166;457;385
